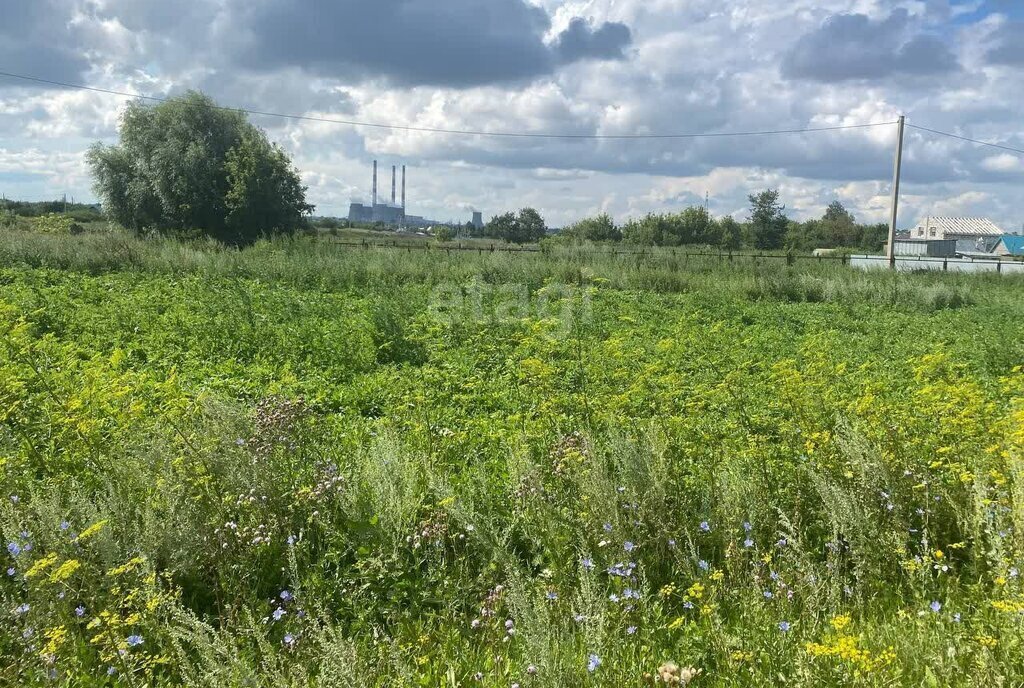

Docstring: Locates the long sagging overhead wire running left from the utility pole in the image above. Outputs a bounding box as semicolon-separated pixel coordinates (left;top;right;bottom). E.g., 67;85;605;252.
0;72;896;140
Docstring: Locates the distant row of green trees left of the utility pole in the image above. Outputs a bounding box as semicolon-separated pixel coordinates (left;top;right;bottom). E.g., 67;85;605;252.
558;189;889;252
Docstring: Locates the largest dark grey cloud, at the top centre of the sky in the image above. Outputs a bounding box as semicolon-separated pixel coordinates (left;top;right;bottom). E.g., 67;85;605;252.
239;0;631;88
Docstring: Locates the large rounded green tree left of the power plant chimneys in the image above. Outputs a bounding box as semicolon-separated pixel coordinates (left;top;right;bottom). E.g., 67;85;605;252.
88;92;313;243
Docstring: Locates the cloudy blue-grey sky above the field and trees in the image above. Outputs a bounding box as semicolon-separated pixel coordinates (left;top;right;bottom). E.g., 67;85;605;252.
0;0;1024;230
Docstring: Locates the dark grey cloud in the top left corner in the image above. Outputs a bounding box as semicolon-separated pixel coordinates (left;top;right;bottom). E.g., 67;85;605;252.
0;0;88;88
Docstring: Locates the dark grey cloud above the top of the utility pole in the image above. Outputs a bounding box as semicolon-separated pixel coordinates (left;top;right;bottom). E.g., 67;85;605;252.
782;9;958;82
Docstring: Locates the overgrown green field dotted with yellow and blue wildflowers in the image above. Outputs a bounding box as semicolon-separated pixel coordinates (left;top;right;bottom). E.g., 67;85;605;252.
0;231;1024;688
